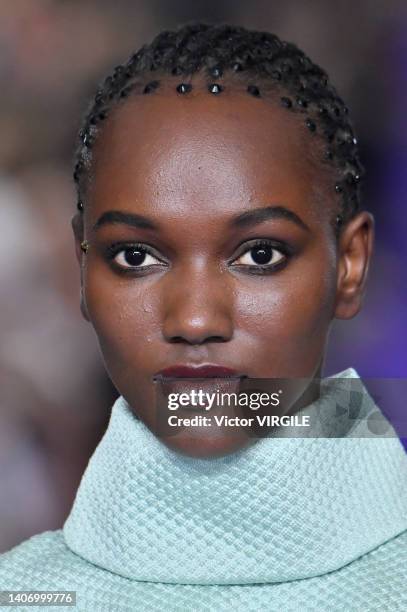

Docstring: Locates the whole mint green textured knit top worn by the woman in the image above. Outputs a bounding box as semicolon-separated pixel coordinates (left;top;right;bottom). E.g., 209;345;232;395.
0;369;407;612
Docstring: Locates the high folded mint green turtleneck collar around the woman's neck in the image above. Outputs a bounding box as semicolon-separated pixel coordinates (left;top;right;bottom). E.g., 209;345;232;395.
63;369;407;585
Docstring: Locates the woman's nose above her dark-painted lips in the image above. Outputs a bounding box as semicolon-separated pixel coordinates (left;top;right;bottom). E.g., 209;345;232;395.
163;268;233;344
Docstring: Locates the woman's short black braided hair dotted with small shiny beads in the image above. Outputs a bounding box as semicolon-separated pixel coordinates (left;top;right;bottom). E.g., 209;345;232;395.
74;23;364;232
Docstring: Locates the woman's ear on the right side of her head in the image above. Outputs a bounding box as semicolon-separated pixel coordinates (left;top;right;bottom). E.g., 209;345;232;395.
334;211;374;319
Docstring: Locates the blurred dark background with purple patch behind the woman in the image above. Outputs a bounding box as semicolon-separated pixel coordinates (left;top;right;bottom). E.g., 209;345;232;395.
0;0;407;552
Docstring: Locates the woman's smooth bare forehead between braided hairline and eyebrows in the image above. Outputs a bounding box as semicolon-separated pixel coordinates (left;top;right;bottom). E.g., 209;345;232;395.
88;87;334;224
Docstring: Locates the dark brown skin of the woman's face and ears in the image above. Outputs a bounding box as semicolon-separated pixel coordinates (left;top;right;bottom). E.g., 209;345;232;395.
72;81;373;457
